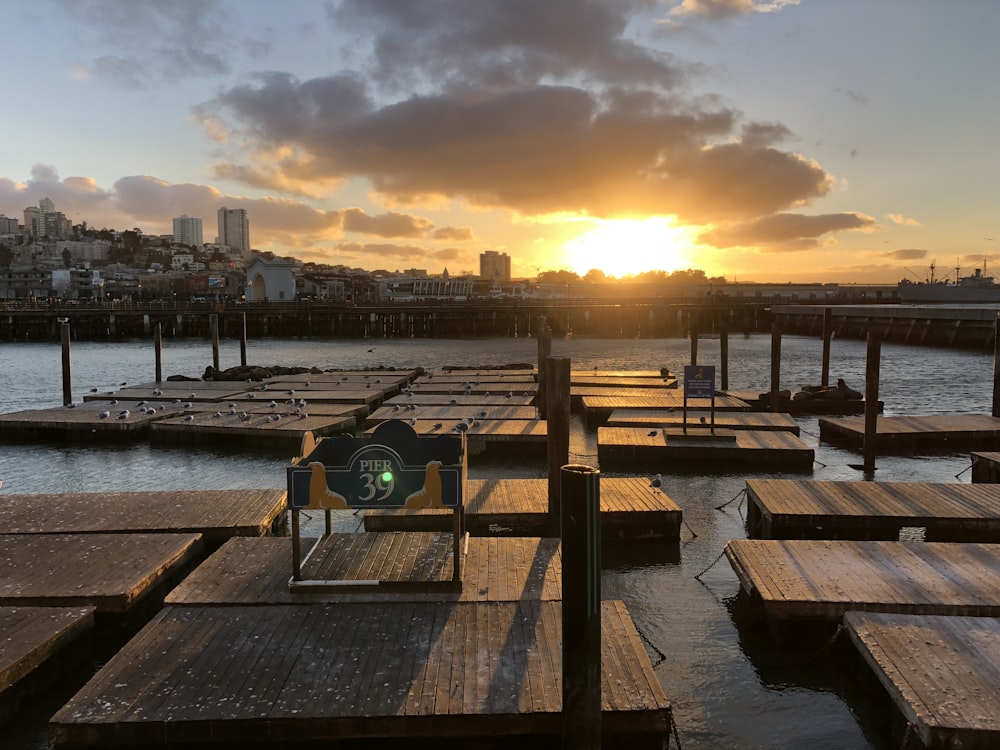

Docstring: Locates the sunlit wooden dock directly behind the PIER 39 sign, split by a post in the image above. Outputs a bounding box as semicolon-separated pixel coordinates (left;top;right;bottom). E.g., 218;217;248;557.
365;477;681;541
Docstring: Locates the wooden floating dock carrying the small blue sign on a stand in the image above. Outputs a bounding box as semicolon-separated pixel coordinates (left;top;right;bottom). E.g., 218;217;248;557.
597;427;815;473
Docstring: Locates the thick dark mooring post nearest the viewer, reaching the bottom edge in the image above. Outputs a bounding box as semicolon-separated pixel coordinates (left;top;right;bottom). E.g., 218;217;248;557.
559;465;601;750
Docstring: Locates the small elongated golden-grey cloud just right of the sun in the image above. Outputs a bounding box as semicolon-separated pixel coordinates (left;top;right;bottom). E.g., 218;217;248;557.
698;212;876;252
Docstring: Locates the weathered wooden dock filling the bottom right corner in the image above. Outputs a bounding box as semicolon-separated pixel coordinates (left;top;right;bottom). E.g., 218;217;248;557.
844;612;1000;750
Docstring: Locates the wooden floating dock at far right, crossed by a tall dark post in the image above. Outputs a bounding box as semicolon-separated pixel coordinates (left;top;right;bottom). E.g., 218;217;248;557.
819;414;1000;453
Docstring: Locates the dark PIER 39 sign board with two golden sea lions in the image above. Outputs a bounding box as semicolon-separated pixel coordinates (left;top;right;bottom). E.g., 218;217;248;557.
288;420;466;510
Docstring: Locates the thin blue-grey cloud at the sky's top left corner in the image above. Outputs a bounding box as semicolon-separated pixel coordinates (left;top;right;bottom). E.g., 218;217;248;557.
56;0;268;89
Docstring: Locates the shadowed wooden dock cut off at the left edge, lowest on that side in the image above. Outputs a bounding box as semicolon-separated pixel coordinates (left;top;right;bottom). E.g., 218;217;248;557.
0;607;94;724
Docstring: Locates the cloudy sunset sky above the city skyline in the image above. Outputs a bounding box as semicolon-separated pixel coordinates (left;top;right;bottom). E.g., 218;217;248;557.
0;0;1000;283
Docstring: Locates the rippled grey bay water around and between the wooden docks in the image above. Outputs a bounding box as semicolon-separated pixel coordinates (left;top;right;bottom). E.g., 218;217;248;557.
0;335;993;750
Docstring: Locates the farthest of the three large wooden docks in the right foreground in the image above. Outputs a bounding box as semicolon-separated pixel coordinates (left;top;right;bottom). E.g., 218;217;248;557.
746;479;1000;542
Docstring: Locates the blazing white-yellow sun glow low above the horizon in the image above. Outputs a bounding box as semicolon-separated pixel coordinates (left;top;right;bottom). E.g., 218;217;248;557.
563;216;699;278
